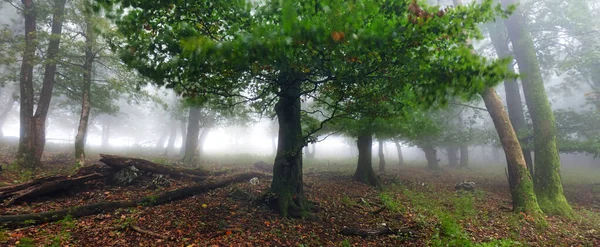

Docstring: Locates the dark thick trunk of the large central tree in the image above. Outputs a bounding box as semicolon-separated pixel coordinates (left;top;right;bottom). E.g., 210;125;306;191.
271;72;308;217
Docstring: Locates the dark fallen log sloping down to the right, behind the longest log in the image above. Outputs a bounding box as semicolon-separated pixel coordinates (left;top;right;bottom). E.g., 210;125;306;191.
100;154;216;179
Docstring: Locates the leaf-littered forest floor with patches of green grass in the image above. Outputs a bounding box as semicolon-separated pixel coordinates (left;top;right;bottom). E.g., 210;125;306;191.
0;155;600;246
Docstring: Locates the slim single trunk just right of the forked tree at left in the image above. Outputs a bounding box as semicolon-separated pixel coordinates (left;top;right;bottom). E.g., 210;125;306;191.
75;12;96;166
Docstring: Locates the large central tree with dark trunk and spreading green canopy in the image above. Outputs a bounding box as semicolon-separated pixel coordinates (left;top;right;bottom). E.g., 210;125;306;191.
98;1;516;216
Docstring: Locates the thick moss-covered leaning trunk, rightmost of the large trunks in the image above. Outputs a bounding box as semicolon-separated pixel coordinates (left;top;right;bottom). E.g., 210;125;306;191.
502;0;573;216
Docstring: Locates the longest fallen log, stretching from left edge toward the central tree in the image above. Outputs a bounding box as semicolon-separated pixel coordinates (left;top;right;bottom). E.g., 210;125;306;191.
0;172;267;229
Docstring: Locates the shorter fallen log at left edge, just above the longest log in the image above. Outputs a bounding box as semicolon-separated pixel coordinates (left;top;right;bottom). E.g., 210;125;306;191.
0;173;104;206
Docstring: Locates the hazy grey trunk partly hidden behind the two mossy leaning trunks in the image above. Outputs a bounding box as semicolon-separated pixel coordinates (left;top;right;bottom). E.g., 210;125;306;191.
489;19;534;177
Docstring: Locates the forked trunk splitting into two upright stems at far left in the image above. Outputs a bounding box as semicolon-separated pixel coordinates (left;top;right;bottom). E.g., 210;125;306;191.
17;0;66;168
